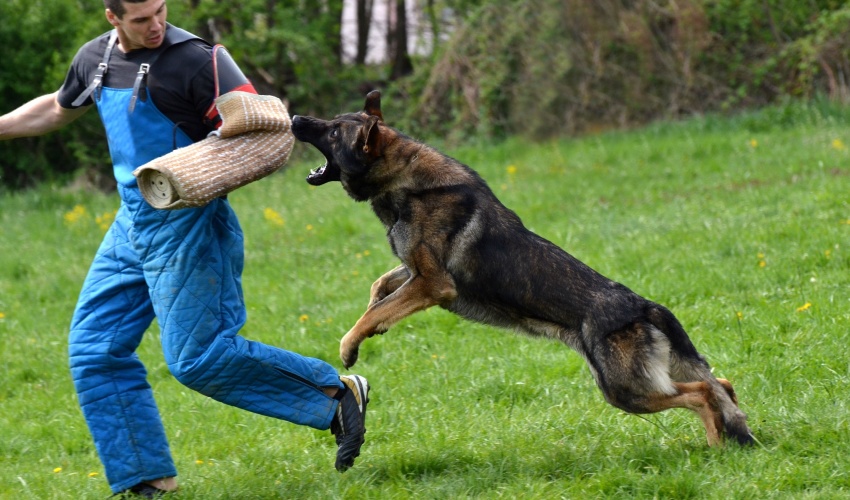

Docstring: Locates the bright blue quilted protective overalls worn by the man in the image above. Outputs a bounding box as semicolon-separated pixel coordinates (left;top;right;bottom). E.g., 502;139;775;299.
69;32;342;492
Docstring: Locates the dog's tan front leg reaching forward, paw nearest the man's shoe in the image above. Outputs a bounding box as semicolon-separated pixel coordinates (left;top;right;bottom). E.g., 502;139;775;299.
339;266;457;368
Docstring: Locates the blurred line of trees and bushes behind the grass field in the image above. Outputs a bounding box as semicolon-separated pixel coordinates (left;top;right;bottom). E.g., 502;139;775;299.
0;0;850;189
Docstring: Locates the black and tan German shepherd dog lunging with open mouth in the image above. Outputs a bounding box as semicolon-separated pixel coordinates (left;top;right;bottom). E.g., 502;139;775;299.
292;91;753;446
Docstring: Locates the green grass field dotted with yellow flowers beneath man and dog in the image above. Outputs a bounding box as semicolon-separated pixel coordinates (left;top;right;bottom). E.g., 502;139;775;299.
0;99;850;499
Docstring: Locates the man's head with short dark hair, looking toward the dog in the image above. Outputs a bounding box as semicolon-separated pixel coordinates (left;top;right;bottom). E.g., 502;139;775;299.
106;0;168;52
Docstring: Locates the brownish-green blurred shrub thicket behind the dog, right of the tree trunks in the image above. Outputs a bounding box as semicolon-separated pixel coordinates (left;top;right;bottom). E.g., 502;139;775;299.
390;0;850;141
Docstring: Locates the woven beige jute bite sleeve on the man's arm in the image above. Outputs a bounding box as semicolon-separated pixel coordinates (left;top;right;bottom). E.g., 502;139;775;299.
133;92;295;210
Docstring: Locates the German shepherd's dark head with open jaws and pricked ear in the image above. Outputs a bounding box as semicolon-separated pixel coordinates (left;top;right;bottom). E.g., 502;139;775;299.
292;90;387;201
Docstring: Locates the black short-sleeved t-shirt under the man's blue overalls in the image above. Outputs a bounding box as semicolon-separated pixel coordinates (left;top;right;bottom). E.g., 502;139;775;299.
58;25;215;141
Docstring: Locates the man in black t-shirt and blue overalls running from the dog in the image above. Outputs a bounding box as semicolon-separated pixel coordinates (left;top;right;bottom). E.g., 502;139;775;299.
0;0;369;497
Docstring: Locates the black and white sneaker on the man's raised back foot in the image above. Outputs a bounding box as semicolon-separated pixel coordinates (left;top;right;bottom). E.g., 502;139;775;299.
331;375;369;472
